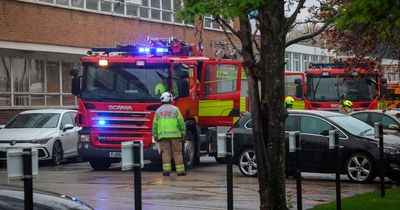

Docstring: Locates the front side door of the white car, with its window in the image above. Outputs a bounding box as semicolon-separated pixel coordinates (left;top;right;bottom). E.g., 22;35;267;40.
59;112;77;157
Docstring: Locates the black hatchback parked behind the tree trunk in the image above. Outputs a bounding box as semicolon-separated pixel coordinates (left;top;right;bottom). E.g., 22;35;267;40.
228;110;400;182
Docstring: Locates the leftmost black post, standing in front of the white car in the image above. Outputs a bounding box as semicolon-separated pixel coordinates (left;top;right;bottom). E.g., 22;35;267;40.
22;148;33;210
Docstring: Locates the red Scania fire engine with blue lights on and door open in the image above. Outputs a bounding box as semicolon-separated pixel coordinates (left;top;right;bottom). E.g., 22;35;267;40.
71;38;246;170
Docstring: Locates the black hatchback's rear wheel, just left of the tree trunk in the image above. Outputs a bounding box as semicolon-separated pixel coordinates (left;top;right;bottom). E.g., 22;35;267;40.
238;148;257;176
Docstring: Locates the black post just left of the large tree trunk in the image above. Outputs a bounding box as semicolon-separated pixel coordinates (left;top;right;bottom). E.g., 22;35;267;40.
226;134;233;210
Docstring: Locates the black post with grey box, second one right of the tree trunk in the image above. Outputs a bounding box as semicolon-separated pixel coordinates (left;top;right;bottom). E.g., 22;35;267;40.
329;130;342;210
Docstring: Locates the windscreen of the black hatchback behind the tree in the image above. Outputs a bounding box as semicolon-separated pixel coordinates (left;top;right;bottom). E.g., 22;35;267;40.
328;115;374;136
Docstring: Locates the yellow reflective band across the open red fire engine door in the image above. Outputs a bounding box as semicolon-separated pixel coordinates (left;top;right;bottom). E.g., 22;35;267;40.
199;100;233;117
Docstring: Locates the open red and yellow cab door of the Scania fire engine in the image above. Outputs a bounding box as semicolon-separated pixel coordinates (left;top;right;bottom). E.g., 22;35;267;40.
198;61;242;126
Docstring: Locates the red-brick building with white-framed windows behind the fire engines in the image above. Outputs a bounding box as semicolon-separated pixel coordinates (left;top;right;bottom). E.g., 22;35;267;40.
0;0;328;124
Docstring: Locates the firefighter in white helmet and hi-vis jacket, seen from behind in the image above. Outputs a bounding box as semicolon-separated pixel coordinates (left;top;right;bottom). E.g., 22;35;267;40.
152;92;186;176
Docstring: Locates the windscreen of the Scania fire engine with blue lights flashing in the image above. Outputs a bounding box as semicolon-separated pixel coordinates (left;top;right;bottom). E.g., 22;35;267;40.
81;64;171;102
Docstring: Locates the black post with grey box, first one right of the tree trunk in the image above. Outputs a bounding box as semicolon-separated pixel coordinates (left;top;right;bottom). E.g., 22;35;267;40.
289;131;303;210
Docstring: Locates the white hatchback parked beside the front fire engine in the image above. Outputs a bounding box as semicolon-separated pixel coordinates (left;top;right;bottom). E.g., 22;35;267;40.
0;109;81;165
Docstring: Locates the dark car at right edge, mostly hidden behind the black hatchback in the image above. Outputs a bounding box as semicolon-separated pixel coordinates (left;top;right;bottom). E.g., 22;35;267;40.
350;110;400;136
